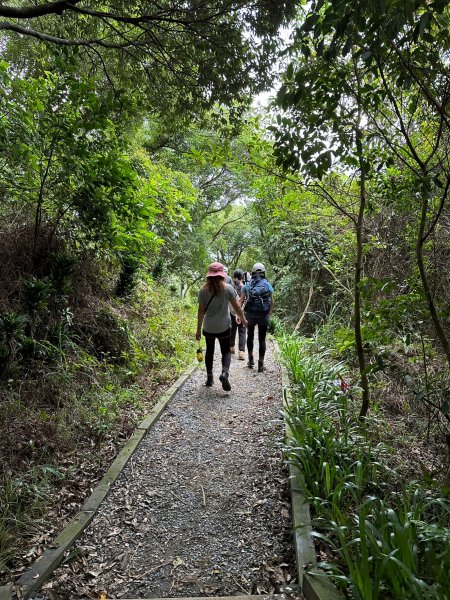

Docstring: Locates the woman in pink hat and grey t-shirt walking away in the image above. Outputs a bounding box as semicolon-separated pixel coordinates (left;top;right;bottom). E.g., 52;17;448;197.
195;262;247;392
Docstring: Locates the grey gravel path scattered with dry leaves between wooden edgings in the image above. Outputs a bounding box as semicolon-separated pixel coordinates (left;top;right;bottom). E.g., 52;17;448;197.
35;344;296;600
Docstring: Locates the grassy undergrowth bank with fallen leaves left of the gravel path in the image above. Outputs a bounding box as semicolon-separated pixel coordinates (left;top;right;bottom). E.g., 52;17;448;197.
0;279;195;574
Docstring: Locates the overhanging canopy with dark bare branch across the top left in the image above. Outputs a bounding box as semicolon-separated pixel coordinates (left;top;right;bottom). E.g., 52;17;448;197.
0;0;296;115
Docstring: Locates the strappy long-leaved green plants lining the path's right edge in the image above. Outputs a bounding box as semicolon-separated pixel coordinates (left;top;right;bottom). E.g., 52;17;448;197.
280;334;450;600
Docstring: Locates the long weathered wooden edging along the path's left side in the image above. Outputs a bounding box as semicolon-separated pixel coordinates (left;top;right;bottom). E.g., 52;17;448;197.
4;364;198;600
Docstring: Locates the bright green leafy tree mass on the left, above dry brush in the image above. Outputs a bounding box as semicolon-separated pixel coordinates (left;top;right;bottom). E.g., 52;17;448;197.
0;56;202;304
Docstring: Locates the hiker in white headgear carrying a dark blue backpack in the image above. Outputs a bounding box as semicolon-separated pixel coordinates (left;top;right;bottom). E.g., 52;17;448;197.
240;263;274;373
